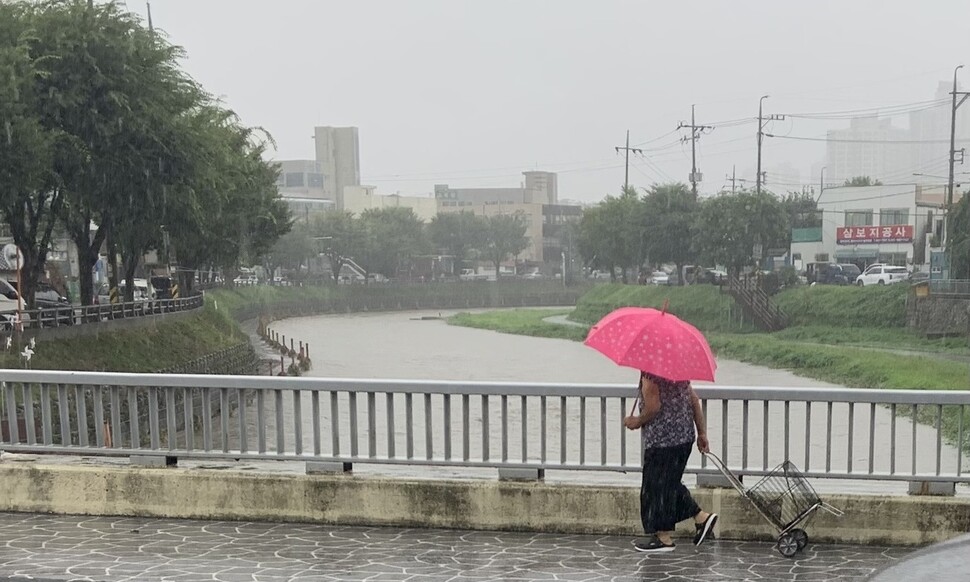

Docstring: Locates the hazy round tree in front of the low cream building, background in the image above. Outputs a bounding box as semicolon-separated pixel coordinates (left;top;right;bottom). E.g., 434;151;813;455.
355;207;428;277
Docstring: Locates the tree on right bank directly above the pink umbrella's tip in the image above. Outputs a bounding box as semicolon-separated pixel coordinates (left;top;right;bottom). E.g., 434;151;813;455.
643;183;700;285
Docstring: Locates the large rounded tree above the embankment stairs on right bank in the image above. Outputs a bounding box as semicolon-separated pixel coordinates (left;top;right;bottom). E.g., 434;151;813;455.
697;190;789;274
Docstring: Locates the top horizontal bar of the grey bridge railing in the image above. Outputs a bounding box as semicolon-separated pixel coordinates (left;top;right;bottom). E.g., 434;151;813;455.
0;369;970;405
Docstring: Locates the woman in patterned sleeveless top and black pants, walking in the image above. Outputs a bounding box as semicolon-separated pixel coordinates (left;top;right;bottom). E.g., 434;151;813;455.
623;372;717;552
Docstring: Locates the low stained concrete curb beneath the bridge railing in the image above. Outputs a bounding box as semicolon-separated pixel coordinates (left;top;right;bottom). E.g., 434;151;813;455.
0;463;970;545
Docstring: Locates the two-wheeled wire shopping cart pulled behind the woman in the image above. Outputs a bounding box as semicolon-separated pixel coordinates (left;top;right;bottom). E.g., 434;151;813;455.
704;453;844;558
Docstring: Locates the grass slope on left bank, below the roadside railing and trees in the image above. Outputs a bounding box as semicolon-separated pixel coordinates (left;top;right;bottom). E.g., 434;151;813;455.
0;305;247;372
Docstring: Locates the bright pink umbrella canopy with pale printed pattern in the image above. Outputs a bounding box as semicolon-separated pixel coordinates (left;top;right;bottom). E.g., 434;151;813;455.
584;307;717;382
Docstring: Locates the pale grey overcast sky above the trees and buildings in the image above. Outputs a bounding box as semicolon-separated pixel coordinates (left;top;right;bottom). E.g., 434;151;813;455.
127;0;970;201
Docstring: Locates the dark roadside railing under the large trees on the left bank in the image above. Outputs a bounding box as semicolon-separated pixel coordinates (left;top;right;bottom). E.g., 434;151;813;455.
0;295;204;332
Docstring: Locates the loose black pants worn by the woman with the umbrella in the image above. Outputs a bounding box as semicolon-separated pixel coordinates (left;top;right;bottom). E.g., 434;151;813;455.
640;443;701;534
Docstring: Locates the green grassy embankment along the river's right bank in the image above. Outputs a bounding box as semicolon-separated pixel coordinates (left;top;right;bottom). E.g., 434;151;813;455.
452;285;970;389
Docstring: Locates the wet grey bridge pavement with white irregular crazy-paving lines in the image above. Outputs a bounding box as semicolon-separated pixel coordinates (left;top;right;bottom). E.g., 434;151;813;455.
0;514;909;582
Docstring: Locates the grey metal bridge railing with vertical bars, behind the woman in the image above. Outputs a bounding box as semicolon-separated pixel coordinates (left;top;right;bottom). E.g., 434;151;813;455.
0;370;970;483
